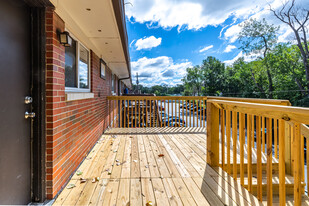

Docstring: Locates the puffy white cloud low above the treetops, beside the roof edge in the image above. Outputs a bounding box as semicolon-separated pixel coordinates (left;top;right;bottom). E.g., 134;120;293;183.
131;56;192;86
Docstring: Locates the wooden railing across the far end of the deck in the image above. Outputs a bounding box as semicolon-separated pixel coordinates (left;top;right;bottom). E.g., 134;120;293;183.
107;96;207;128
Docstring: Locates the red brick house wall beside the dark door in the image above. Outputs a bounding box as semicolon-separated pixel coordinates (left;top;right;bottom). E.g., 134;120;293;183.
46;9;117;199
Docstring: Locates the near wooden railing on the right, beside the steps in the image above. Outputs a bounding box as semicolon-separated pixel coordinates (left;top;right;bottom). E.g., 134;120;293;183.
207;97;309;205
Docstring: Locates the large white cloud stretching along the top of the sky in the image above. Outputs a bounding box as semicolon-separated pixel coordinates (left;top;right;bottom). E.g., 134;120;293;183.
126;0;267;31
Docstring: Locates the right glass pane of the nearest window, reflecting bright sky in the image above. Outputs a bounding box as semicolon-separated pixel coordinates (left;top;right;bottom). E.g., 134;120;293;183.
78;45;89;89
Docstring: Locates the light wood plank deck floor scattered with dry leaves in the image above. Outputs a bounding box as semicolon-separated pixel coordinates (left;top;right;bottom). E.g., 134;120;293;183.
54;128;262;206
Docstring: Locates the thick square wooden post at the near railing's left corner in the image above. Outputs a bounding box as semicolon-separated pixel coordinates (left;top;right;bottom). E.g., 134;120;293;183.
207;102;219;167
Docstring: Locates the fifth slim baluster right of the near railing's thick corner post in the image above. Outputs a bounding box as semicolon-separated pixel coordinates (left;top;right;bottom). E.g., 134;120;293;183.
247;114;254;192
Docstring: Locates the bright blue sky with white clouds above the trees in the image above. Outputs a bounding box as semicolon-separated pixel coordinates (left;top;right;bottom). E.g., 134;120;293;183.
125;0;306;86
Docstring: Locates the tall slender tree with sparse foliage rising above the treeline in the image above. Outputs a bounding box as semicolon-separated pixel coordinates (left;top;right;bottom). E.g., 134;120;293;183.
238;19;279;98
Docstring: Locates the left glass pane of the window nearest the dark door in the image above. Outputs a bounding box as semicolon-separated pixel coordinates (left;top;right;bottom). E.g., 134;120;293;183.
65;40;77;87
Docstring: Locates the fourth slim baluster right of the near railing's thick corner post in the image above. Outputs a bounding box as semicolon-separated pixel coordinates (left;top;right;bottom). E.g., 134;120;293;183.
239;113;244;186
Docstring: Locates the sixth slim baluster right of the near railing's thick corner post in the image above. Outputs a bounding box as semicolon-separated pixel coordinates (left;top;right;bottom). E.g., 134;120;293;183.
256;116;263;201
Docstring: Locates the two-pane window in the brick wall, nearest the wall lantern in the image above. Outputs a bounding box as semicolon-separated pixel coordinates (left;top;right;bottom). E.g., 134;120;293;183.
65;39;90;92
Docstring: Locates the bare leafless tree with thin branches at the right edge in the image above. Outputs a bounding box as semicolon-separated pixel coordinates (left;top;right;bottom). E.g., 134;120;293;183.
270;0;309;94
